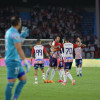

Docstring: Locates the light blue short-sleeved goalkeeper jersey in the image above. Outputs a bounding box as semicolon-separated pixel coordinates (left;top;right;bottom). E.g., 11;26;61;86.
5;27;21;61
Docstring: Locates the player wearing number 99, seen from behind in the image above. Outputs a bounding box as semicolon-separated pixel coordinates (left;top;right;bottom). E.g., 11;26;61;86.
31;39;49;84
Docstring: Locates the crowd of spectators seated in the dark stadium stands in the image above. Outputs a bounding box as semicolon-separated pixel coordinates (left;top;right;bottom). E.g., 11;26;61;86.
0;6;98;57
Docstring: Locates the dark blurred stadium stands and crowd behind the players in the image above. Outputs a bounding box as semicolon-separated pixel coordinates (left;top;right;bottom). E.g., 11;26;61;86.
0;0;100;59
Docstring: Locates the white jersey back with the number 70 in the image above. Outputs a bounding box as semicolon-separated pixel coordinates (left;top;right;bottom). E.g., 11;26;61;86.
63;43;74;62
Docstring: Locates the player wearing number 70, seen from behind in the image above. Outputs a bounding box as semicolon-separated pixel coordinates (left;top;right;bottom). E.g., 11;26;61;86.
61;37;78;85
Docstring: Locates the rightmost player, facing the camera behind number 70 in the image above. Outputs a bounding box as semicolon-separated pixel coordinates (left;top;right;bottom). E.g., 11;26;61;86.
75;38;86;77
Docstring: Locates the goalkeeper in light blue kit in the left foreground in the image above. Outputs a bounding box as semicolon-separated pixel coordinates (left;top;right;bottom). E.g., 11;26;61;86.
5;16;30;100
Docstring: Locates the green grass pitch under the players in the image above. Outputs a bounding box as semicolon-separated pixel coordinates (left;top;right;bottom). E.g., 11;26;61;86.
0;67;100;100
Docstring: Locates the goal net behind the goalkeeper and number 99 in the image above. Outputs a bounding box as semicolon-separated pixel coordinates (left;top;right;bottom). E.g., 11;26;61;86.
0;39;53;58
